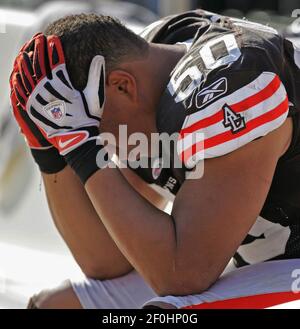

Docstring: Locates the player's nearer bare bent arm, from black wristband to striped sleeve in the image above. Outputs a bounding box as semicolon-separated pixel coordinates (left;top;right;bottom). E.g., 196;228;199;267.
86;120;291;295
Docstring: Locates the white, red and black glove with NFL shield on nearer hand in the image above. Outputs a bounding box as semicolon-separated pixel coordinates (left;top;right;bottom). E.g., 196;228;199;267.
11;34;105;155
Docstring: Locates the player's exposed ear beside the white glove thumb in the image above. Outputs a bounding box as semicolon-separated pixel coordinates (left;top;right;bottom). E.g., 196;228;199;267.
107;70;138;102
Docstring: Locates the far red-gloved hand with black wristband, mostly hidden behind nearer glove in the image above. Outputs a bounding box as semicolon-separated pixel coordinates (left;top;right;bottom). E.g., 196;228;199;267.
10;37;66;174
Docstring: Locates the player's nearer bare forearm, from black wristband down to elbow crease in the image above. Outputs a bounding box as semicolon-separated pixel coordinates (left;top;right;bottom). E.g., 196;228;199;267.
86;169;186;294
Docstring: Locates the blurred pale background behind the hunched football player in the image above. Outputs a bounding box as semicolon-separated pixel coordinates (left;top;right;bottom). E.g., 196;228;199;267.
0;0;300;308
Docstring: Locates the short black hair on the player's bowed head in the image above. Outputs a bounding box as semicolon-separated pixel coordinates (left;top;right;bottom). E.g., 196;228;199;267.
45;14;148;90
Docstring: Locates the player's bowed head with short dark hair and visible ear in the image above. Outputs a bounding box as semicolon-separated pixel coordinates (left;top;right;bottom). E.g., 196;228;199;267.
45;14;149;135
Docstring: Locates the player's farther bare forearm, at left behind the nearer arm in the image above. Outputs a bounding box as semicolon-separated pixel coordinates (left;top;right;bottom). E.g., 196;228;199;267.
43;167;132;279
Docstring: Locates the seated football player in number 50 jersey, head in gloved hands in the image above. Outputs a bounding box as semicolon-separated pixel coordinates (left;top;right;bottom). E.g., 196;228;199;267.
10;10;300;308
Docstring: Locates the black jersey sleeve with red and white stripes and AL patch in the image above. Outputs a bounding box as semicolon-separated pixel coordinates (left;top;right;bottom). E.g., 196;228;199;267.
176;37;289;168
